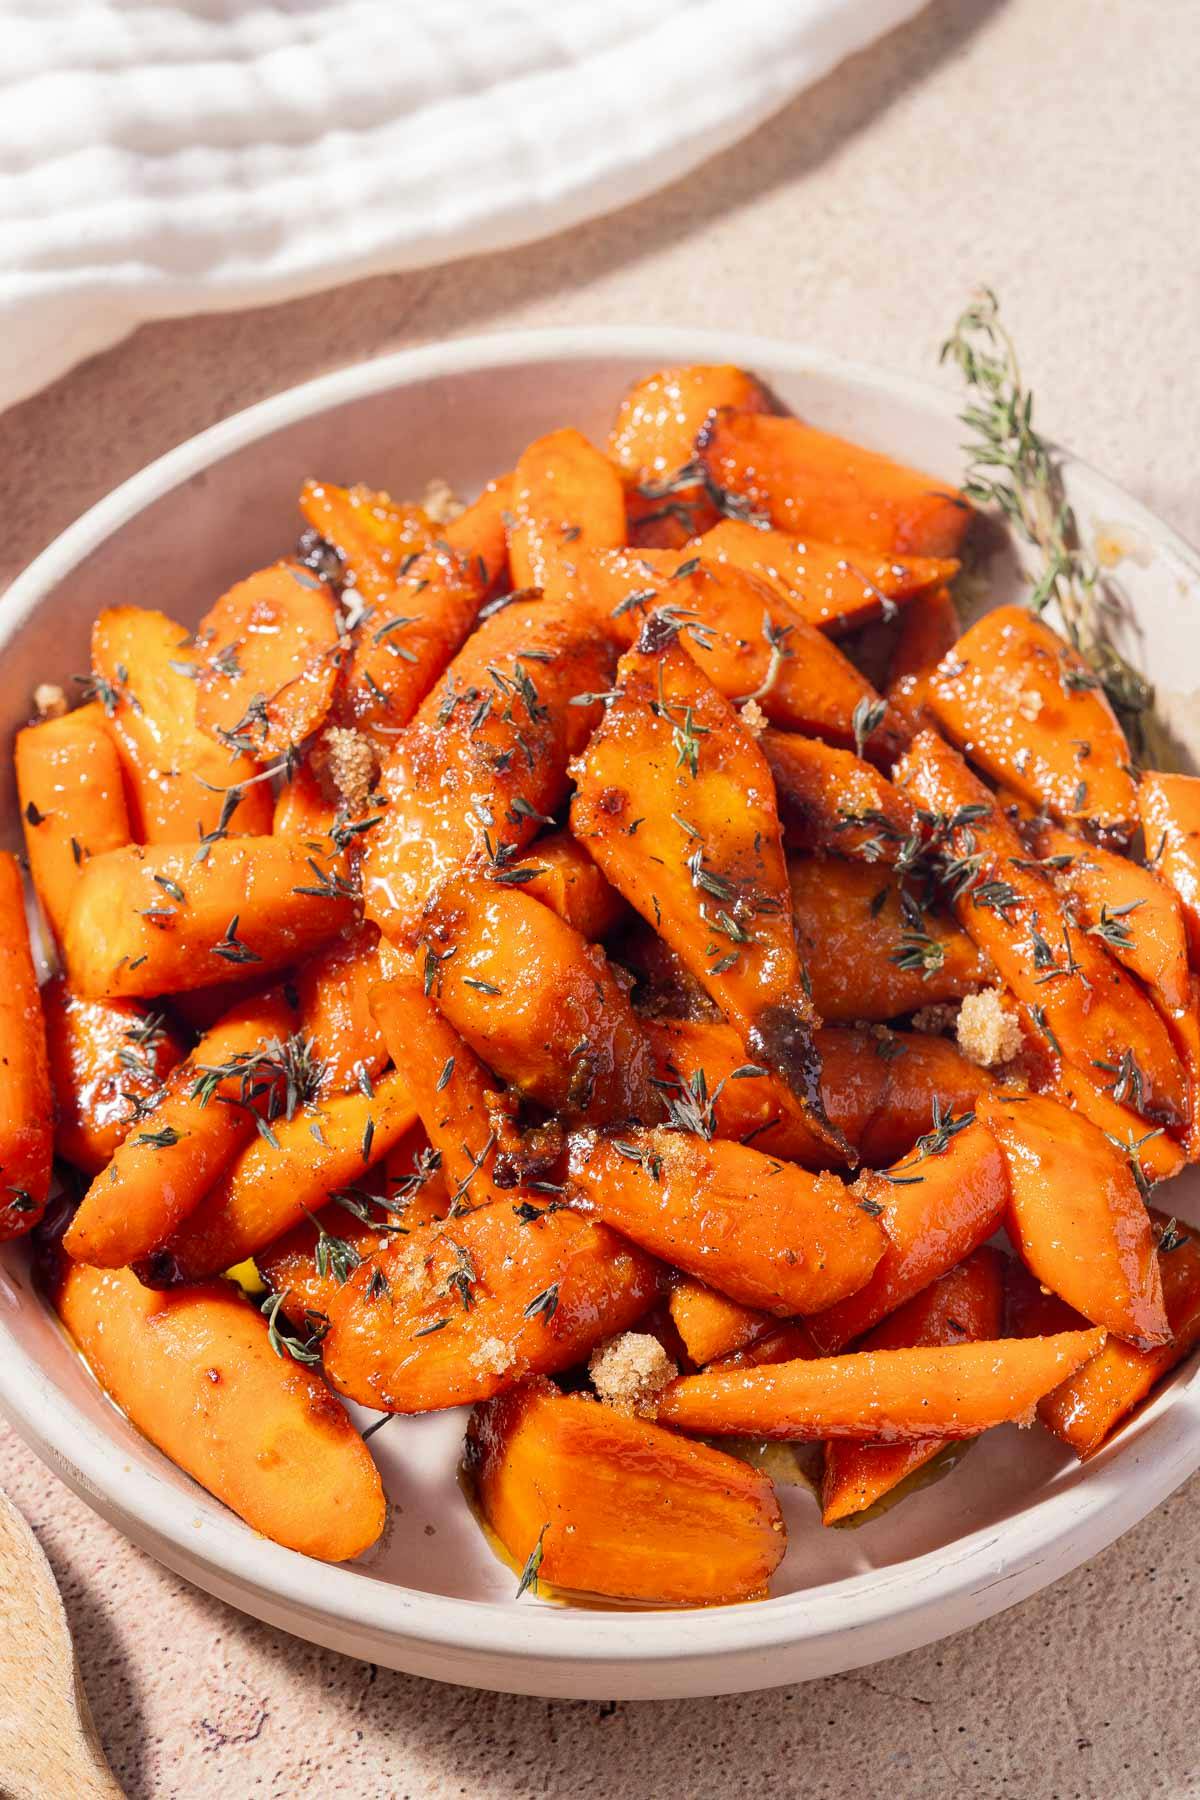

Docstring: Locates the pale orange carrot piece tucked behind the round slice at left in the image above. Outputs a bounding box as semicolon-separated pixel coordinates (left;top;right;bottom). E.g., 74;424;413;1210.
92;607;272;844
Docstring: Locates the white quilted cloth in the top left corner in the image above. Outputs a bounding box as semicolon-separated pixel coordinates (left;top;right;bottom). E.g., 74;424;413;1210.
0;0;921;405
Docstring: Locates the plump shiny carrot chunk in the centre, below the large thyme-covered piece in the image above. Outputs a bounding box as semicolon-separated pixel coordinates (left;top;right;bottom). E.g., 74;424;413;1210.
421;875;660;1125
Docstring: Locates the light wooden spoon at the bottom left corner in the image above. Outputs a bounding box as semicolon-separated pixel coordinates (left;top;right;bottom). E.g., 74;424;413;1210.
0;1494;121;1800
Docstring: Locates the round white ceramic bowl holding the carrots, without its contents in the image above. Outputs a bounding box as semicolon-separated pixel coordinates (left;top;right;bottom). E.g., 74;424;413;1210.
0;328;1200;1699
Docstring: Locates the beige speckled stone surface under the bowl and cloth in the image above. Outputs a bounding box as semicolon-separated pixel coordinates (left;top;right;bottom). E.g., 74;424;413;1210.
0;0;1200;1800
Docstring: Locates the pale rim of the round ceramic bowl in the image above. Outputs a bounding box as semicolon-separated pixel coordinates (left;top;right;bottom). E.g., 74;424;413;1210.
0;326;1200;1670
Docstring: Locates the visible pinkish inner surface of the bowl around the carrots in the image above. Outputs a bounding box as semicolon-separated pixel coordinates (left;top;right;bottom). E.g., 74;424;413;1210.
0;333;1200;1656
